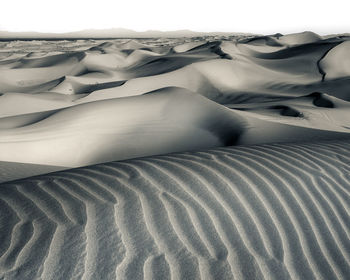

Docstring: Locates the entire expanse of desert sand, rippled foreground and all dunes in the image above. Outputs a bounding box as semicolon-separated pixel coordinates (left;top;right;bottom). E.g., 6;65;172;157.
0;32;350;280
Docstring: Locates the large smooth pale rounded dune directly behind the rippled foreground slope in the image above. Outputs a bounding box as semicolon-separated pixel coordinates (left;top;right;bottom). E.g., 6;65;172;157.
0;88;244;167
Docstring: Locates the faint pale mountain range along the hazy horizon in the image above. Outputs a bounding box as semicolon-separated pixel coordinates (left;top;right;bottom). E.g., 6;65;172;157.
0;28;249;39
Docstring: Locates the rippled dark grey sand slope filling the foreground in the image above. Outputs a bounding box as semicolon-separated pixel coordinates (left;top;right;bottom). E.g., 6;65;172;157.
0;141;350;279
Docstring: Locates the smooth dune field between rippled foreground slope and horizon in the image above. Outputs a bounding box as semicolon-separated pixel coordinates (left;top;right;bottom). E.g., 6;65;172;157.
0;32;350;175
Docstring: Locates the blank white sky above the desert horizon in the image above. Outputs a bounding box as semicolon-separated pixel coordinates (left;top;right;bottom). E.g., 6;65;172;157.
0;0;350;34
